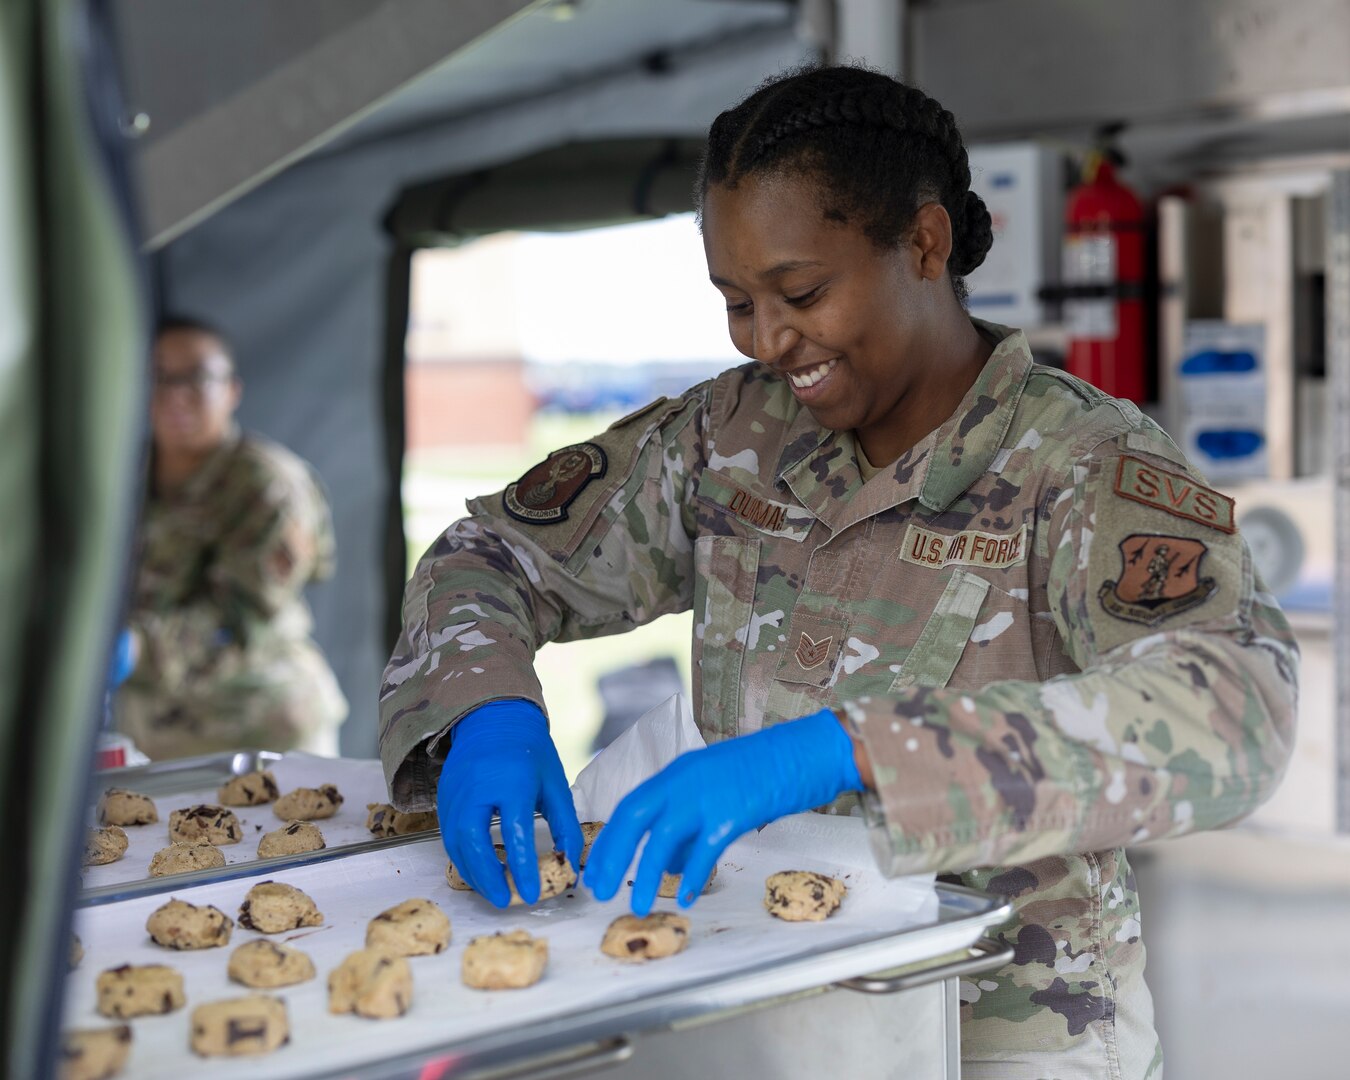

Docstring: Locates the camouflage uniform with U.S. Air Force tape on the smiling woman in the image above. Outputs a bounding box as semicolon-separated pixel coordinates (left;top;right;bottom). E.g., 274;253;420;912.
381;324;1297;1079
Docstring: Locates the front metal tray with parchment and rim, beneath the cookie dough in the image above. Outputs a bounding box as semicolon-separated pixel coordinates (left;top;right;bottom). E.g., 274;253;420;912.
66;836;1010;1080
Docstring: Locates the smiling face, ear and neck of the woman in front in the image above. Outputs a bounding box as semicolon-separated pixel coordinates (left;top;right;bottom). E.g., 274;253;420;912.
702;173;992;466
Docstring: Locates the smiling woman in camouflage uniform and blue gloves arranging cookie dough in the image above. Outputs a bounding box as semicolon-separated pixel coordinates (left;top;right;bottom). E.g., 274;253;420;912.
381;68;1299;1080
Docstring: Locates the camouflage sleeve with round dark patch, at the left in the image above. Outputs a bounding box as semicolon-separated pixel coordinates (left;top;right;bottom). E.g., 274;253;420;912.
379;389;706;810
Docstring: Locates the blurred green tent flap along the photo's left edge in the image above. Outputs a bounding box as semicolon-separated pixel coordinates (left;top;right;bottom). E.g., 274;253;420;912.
0;0;146;1079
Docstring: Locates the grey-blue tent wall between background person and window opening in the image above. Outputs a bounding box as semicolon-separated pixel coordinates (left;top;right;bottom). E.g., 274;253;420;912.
158;160;387;757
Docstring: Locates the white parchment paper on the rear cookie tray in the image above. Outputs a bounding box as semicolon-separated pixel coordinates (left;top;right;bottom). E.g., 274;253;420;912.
82;751;399;890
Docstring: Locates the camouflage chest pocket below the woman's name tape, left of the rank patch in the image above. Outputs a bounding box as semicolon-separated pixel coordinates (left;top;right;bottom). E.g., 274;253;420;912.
693;536;760;741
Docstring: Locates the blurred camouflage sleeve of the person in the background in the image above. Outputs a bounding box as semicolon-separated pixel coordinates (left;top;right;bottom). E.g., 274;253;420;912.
130;462;335;689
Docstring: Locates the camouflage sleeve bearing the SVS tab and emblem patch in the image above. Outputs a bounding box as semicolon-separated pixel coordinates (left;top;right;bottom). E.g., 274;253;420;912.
845;433;1297;873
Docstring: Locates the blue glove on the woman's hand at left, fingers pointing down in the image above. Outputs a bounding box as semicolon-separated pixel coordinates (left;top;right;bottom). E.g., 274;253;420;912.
436;701;582;907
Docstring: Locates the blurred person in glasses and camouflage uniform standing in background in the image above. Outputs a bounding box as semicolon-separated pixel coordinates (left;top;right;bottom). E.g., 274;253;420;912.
115;319;347;759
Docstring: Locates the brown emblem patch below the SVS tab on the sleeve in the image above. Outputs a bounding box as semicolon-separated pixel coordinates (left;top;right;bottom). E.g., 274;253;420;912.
1098;533;1218;626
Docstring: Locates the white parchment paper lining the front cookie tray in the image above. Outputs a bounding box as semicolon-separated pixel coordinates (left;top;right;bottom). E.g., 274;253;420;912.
65;815;950;1080
